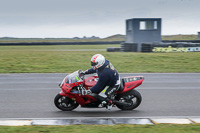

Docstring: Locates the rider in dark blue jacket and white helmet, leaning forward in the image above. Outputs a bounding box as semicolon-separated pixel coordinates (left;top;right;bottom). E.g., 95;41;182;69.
82;54;120;106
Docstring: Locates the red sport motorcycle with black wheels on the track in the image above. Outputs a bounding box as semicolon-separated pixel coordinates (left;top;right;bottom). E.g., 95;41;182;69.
54;70;144;111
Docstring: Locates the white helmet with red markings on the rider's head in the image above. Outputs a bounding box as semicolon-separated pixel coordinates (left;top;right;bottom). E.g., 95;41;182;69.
91;54;105;70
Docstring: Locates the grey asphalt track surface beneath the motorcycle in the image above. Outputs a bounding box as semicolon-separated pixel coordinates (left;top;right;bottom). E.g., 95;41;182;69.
0;73;200;118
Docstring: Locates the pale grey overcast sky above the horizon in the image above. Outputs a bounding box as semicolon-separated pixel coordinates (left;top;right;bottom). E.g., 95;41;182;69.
0;0;200;38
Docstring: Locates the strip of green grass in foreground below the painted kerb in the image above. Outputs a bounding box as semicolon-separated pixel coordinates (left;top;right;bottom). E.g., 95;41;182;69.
0;124;200;133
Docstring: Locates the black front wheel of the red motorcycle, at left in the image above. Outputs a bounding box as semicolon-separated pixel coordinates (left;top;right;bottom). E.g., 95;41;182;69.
54;94;79;111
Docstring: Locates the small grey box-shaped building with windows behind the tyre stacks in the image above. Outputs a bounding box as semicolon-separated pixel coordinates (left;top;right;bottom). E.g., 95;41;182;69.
125;18;162;52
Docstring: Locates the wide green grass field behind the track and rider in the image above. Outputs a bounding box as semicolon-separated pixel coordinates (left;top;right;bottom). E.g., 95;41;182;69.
0;45;200;73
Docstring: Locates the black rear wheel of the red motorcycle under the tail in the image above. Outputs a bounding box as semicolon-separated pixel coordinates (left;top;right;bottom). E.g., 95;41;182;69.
116;90;142;110
